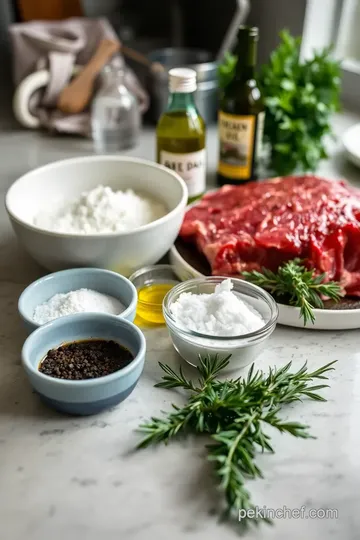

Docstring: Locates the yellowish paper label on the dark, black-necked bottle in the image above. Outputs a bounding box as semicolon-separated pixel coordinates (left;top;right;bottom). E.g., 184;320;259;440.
218;111;256;180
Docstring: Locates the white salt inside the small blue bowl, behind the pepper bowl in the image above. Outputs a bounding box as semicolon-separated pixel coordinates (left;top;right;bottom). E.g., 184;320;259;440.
33;289;125;324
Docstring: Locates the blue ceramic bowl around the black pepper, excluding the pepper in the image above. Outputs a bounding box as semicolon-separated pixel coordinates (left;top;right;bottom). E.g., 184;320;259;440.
22;313;146;415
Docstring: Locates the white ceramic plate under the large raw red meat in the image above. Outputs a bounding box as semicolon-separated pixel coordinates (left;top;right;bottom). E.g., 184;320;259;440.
170;245;360;330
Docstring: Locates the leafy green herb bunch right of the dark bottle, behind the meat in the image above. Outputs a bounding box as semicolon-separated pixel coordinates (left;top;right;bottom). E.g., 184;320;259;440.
258;30;341;175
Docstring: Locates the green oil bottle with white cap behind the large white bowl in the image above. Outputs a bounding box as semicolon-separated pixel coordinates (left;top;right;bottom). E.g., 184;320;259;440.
156;68;206;202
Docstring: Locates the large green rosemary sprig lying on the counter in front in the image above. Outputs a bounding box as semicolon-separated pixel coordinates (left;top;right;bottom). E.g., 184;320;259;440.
138;356;335;524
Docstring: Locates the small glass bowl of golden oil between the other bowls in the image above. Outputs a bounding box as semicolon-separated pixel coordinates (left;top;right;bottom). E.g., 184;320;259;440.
129;264;190;325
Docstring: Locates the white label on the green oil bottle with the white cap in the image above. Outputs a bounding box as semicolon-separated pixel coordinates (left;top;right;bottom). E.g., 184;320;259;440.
160;150;206;197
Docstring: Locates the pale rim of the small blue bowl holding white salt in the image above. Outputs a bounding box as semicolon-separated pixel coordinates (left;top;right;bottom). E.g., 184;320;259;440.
18;267;137;328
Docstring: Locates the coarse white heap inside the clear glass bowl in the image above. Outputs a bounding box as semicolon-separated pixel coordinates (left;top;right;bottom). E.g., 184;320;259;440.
170;279;265;336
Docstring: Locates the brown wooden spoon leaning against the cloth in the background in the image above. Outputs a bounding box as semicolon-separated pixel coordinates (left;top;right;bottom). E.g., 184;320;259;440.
57;39;120;114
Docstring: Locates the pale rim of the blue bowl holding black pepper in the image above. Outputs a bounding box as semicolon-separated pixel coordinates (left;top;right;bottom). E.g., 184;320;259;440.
21;313;146;388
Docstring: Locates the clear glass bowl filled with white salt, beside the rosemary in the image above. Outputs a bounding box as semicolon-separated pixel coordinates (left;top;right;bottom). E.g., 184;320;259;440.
163;277;279;373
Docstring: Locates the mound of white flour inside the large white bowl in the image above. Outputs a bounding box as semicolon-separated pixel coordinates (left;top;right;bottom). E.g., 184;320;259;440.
34;185;167;234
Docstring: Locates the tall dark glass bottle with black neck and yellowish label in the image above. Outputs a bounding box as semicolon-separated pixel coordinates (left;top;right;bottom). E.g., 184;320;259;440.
217;26;265;185
